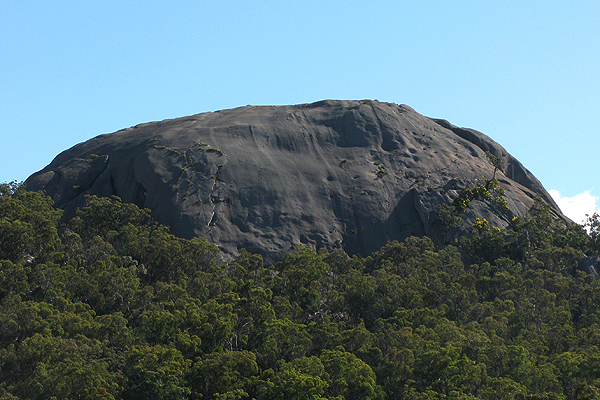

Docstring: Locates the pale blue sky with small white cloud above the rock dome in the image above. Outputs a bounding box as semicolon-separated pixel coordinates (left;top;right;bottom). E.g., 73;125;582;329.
0;0;600;223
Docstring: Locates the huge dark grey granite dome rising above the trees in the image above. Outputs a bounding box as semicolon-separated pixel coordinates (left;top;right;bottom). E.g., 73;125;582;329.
26;100;560;262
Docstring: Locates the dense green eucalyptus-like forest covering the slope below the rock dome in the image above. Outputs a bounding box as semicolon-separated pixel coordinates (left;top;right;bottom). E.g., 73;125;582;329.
0;183;600;400
